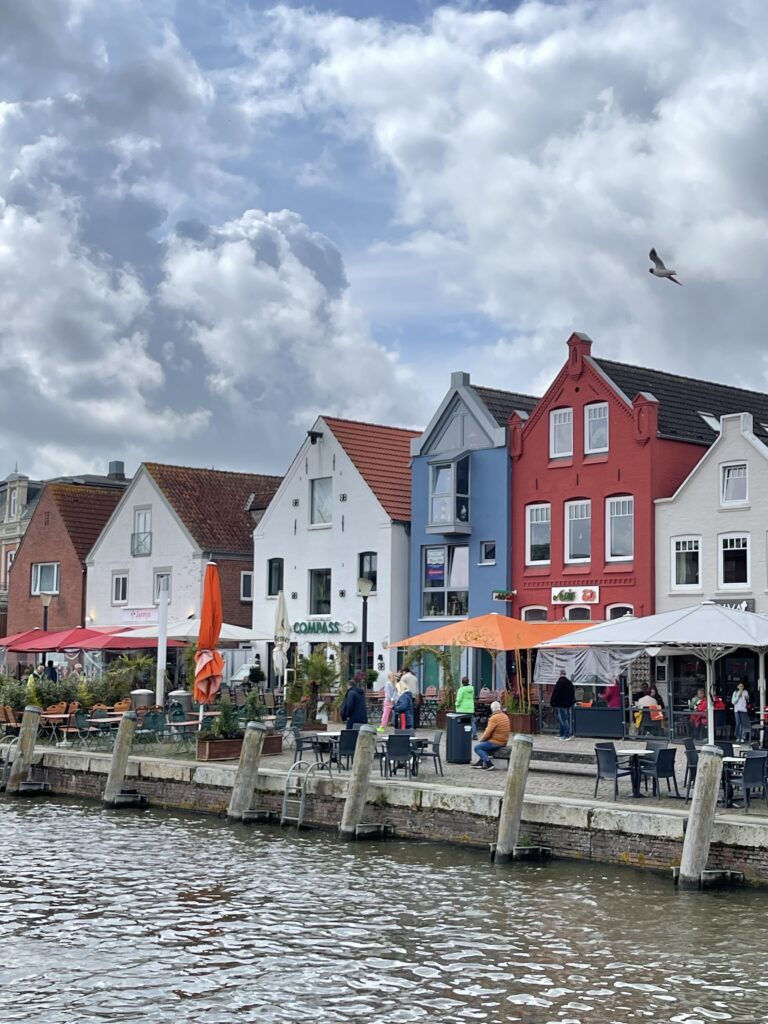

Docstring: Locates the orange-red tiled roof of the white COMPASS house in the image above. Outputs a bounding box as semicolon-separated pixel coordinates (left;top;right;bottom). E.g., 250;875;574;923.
323;416;421;522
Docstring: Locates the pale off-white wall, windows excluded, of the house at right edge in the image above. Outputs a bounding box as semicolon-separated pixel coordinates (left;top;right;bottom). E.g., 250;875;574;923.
655;413;768;613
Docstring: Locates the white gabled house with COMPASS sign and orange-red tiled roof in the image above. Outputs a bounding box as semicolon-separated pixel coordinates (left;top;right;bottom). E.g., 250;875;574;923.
253;417;418;681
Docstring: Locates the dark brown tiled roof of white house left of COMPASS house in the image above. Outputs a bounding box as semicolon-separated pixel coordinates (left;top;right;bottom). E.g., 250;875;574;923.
144;462;283;556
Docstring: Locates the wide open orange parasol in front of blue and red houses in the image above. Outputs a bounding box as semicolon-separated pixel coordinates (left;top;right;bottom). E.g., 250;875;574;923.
389;611;584;650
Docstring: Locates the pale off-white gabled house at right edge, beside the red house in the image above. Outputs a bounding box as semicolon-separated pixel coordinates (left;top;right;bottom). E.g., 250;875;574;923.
655;413;768;613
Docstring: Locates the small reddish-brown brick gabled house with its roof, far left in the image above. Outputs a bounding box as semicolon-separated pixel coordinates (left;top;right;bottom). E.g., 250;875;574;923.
8;481;126;633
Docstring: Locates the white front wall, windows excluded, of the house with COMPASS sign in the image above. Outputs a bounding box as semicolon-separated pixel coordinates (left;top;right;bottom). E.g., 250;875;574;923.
253;420;409;671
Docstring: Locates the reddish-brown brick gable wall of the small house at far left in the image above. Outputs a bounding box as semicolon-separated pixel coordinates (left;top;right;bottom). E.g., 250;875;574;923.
8;488;85;634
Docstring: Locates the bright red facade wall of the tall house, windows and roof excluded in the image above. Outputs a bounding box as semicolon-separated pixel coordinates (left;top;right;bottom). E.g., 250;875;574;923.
510;338;706;620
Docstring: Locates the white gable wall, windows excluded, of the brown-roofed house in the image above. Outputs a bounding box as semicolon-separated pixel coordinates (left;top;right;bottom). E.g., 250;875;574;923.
85;467;204;626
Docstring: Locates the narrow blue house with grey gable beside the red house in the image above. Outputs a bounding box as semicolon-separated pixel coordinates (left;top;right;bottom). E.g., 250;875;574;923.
410;373;539;687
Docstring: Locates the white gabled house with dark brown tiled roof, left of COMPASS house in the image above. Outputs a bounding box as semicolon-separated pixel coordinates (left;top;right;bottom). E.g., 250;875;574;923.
85;463;281;627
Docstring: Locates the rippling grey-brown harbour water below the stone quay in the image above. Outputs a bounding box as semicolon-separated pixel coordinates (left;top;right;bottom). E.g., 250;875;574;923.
0;801;768;1024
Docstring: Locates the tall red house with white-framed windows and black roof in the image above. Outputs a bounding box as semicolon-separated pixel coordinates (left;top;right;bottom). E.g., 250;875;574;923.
509;334;768;621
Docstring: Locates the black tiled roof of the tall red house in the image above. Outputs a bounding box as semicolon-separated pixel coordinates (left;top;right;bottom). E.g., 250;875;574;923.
593;358;768;444
